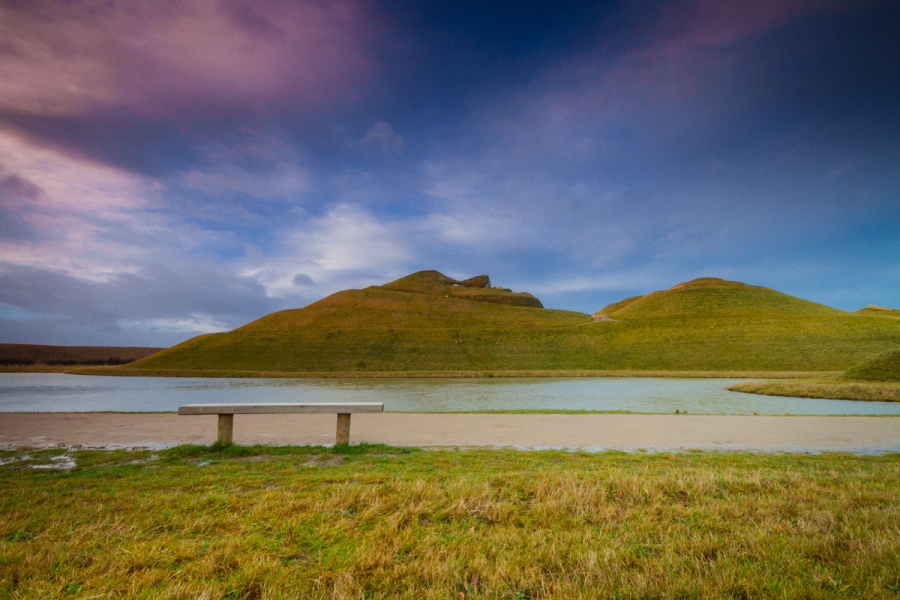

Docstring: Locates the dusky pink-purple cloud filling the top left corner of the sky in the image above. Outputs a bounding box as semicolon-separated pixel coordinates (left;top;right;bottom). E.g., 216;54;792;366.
0;0;380;114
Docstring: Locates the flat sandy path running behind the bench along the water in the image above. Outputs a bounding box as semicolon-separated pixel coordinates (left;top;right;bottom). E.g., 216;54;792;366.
0;413;900;452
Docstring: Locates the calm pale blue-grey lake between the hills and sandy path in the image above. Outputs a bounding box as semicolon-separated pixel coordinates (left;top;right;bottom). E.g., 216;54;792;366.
0;373;900;415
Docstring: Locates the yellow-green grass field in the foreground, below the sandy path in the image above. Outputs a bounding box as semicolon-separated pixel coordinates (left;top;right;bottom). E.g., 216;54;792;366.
0;447;900;599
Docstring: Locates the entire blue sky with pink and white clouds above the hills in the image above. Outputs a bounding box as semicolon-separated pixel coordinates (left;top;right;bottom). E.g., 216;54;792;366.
0;0;900;346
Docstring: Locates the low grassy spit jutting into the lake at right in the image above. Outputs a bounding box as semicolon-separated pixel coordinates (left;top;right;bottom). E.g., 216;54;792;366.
728;379;900;402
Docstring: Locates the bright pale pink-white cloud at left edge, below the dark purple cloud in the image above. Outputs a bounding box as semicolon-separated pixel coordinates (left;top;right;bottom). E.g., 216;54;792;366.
0;131;169;279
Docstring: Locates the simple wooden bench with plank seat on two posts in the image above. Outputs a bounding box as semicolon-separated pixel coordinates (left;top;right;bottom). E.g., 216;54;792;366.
178;402;384;446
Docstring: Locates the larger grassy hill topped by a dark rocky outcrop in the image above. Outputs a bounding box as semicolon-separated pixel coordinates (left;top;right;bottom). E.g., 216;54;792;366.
132;271;591;372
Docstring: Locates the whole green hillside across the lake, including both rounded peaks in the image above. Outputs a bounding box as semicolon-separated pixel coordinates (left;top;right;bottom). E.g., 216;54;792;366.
129;271;900;373
